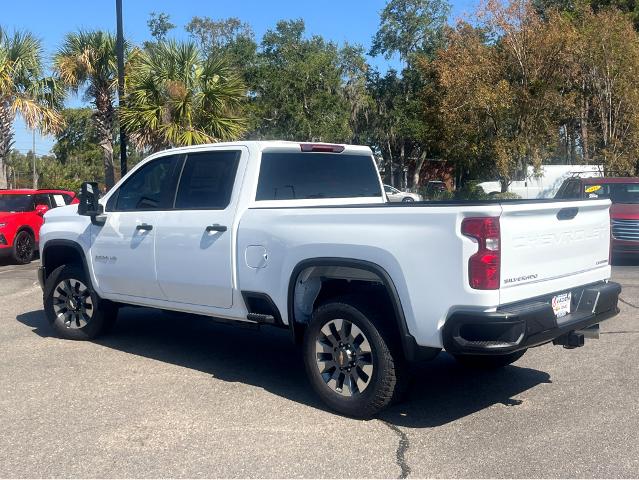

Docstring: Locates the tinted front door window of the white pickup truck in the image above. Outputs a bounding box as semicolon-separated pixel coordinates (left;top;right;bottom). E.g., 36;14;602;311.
113;156;177;212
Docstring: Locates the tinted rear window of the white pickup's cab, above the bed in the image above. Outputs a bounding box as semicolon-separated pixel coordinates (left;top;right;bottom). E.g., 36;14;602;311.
255;152;382;200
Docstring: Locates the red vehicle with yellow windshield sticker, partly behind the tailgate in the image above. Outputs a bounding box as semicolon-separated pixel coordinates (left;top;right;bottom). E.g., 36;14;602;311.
555;177;639;255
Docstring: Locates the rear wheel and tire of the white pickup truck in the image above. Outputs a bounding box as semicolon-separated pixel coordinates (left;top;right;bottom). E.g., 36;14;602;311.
303;297;406;418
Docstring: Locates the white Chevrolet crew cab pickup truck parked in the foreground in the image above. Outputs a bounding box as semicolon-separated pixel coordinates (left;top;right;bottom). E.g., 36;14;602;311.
39;141;620;417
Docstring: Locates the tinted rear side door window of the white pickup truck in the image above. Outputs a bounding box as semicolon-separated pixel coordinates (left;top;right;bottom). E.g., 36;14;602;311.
175;151;240;210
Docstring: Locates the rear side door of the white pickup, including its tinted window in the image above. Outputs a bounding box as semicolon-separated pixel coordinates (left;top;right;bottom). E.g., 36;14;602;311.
155;147;248;308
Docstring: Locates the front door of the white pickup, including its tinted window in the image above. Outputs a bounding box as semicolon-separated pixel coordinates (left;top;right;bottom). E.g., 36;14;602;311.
91;156;178;299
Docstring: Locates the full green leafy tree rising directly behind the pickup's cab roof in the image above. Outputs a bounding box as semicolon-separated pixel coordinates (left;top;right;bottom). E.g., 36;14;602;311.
249;20;353;142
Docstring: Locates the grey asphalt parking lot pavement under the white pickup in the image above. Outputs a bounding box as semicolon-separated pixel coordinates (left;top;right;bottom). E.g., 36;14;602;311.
0;256;639;477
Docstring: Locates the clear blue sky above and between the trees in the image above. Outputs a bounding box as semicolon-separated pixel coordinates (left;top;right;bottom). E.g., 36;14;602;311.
0;0;476;154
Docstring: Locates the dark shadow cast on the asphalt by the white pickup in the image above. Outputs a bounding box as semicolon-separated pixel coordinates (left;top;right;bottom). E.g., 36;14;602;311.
17;308;550;427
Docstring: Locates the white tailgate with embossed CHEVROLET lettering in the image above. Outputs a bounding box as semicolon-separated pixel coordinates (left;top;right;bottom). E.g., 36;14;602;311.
500;200;610;304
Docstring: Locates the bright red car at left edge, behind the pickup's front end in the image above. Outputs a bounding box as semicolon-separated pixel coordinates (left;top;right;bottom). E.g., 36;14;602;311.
0;190;78;264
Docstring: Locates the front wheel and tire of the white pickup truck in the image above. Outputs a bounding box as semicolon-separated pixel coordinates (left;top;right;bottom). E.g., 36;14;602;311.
44;265;117;340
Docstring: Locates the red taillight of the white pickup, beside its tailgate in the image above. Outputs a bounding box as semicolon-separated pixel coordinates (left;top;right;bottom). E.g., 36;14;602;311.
462;217;501;290
